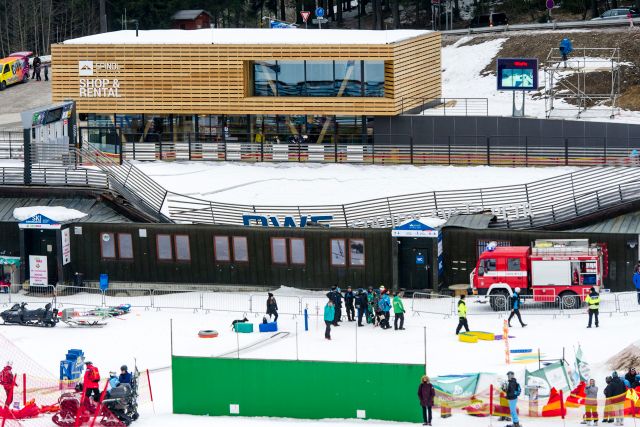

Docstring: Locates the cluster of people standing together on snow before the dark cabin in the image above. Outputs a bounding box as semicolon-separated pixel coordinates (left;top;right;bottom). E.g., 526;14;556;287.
324;286;406;340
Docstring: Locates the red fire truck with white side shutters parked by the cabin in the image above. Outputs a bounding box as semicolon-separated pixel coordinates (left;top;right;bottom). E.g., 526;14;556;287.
471;239;604;311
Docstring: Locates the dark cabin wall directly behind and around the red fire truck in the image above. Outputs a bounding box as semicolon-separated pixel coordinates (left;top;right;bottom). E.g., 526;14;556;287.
443;227;638;291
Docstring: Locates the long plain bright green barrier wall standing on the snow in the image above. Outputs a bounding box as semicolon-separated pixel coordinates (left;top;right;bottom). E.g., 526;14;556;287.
172;356;424;422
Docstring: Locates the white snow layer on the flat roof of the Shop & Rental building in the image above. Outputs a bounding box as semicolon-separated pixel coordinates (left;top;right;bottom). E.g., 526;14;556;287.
64;28;431;45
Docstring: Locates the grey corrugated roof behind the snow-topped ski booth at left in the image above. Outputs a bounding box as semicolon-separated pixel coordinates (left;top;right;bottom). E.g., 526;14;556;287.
0;197;132;223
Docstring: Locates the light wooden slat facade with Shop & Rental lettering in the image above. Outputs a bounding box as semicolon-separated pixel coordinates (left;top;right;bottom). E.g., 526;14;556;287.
52;33;441;116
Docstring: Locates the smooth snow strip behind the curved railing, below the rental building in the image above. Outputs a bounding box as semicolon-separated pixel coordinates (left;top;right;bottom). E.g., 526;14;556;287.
136;162;576;205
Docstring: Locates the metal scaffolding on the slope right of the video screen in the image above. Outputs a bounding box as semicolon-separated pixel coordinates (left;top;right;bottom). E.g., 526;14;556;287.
544;48;620;118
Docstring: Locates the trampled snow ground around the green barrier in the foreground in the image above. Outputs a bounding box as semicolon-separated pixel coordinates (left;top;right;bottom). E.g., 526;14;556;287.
0;289;640;427
